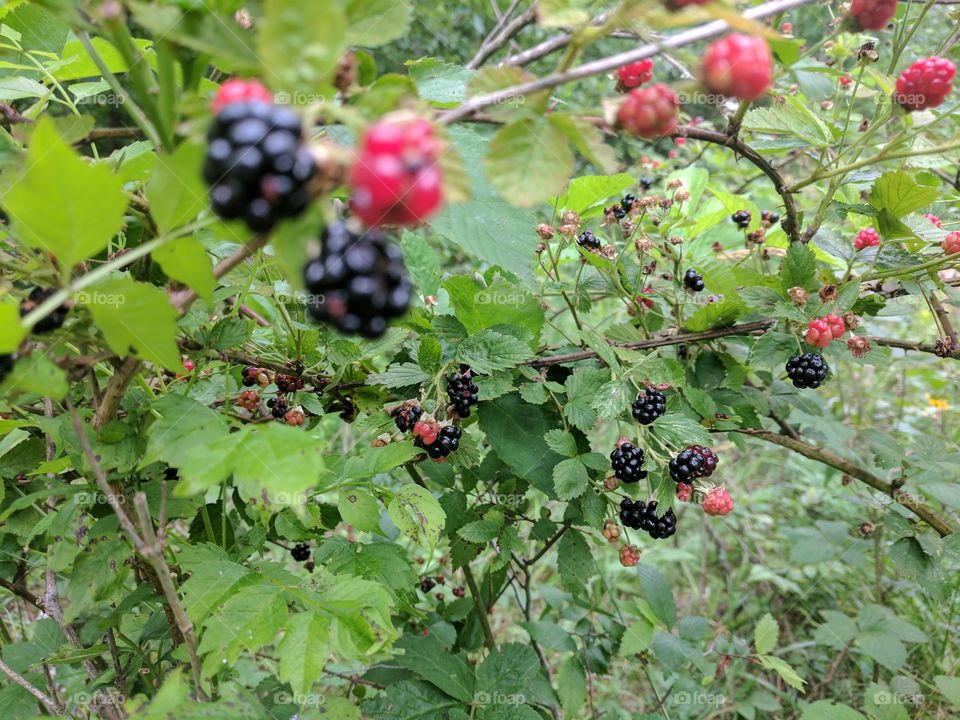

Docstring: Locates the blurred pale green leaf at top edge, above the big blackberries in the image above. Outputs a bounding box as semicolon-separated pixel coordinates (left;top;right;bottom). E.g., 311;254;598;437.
257;0;346;97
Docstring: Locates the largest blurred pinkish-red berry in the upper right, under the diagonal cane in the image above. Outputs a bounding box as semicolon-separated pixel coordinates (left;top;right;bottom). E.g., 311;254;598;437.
703;33;773;100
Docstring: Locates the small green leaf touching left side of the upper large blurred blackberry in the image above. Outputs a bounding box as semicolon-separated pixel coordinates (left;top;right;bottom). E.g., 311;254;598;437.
146;143;207;236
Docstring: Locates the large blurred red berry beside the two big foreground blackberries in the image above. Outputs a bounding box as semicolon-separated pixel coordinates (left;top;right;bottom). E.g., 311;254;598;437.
350;117;443;227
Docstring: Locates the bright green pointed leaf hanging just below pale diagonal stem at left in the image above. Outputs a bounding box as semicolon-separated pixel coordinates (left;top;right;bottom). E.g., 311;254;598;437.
83;276;180;370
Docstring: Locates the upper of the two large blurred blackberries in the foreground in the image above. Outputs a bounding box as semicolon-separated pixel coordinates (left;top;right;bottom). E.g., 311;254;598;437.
203;102;316;232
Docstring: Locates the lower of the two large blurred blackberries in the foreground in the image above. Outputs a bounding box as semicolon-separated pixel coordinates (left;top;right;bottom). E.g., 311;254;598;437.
303;222;413;339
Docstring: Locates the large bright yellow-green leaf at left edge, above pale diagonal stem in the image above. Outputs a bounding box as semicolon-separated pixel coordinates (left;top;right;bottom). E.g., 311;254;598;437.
0;117;127;270
